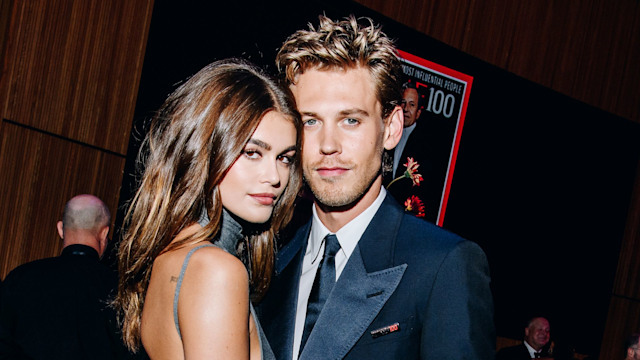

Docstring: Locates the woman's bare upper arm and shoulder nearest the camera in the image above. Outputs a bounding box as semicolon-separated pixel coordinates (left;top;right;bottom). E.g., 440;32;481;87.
178;247;249;360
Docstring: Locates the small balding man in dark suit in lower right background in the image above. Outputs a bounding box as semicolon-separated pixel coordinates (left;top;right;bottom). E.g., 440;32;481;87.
496;317;551;360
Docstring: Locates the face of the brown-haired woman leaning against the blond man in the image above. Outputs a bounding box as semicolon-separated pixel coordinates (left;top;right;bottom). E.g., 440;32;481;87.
219;111;296;223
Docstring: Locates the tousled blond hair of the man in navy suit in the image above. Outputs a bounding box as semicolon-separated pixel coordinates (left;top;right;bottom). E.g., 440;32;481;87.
276;15;402;118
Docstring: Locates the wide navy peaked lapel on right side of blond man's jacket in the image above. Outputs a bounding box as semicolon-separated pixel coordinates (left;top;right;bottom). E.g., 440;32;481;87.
300;197;407;360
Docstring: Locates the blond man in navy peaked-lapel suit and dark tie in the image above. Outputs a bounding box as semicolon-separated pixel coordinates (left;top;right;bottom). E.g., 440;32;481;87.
260;17;495;360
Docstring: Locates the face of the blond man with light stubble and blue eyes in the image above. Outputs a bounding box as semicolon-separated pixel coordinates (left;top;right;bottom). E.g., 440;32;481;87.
291;68;384;207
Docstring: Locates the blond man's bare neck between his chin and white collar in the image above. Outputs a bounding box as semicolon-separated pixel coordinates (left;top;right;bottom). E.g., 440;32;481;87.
315;175;382;233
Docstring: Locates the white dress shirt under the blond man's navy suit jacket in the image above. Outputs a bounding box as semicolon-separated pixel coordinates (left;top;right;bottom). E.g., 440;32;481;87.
293;187;387;360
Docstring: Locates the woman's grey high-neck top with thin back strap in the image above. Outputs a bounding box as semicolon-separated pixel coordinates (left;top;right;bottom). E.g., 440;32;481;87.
173;210;276;360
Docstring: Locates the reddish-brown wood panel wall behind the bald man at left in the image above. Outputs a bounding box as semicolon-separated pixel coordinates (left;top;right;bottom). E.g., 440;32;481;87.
0;0;153;278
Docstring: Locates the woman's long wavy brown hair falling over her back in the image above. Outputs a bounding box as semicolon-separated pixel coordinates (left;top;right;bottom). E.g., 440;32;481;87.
114;59;302;351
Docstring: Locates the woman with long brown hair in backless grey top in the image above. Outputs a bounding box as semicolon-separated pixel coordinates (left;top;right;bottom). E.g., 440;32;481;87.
115;60;301;359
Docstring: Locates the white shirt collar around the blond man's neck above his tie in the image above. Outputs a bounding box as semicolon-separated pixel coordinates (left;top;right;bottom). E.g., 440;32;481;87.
307;187;387;258
